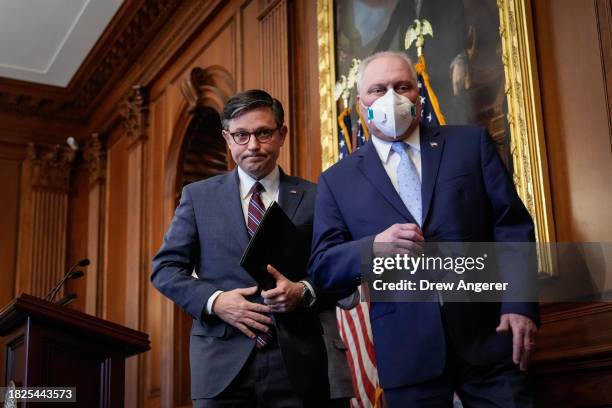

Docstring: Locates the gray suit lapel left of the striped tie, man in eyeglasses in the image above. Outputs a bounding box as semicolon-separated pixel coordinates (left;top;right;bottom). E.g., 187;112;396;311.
217;169;249;251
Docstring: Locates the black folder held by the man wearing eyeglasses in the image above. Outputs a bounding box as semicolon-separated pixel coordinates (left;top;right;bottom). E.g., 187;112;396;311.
240;201;304;290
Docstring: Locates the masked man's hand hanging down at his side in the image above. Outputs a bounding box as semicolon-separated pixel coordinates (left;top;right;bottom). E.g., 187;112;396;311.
496;313;538;371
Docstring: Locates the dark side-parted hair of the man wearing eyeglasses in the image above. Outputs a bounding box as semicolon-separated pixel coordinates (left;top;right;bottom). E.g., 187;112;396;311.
221;89;285;129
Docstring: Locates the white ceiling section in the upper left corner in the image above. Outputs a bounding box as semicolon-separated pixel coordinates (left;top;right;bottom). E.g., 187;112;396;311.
0;0;124;87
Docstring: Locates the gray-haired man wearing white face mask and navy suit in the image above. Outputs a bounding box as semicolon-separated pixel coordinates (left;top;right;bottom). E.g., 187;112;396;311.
309;52;539;407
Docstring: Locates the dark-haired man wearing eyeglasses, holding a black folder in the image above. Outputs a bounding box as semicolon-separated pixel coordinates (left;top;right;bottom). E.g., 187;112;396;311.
151;90;353;408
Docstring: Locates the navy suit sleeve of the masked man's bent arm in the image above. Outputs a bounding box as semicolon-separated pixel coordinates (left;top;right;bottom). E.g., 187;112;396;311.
308;174;374;297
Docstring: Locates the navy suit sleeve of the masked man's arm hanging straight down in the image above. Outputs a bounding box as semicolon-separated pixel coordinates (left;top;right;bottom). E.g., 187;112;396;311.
480;129;539;323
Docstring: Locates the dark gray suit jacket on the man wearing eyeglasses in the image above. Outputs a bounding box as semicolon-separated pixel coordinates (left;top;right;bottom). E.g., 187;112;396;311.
151;170;352;399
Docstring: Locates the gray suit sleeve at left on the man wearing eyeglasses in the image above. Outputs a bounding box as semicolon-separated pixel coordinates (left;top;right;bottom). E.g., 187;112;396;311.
151;188;218;323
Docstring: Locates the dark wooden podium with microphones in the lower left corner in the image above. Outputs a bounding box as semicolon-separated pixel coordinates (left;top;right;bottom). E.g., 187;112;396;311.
0;294;150;408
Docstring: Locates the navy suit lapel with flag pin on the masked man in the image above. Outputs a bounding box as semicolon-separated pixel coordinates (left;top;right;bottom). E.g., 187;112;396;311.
420;126;445;225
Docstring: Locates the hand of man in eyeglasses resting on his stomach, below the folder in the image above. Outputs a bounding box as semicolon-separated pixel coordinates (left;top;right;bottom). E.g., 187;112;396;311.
212;286;272;339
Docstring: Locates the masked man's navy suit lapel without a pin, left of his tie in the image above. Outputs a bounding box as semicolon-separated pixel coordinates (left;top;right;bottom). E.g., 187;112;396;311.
357;141;415;223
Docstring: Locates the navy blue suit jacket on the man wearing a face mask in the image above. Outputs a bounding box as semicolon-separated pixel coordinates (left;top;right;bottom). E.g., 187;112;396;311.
309;126;538;388
